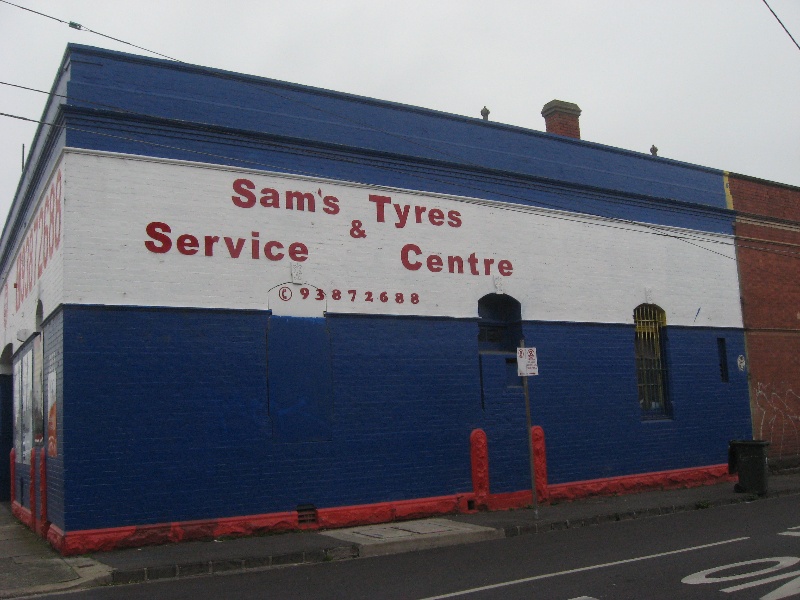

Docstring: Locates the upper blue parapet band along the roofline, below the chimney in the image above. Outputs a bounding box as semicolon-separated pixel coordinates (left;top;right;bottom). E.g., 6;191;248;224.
69;45;726;208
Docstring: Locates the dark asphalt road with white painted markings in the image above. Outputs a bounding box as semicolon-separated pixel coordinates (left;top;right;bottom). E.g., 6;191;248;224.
39;496;800;600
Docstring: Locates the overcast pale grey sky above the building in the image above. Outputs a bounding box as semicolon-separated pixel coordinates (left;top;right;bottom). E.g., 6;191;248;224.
0;0;800;225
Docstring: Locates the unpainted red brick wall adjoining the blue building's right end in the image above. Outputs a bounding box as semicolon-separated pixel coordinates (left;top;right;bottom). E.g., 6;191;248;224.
729;176;800;465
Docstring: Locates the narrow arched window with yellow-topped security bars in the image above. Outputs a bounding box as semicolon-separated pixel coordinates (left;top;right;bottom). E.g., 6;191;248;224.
633;304;669;418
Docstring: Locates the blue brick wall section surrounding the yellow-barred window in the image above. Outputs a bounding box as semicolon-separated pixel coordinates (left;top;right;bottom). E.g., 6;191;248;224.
524;323;750;483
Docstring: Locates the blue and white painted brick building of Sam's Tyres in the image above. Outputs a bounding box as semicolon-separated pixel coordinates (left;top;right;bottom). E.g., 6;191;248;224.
0;45;751;553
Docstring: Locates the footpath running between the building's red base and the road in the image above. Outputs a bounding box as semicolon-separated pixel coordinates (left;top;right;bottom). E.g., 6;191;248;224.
0;473;800;598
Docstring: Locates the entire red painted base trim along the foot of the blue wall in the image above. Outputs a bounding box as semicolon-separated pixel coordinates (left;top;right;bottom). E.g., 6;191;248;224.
31;464;735;556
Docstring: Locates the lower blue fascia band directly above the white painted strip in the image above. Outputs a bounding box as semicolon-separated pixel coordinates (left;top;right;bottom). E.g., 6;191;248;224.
64;106;733;234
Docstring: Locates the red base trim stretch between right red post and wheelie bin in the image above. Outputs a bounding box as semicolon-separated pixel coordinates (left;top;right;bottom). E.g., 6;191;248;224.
547;464;735;501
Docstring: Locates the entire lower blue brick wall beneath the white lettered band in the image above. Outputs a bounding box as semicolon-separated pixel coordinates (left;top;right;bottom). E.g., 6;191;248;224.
62;307;749;530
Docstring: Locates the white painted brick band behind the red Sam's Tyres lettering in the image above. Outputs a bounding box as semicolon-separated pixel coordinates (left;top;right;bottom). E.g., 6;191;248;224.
64;150;742;327
